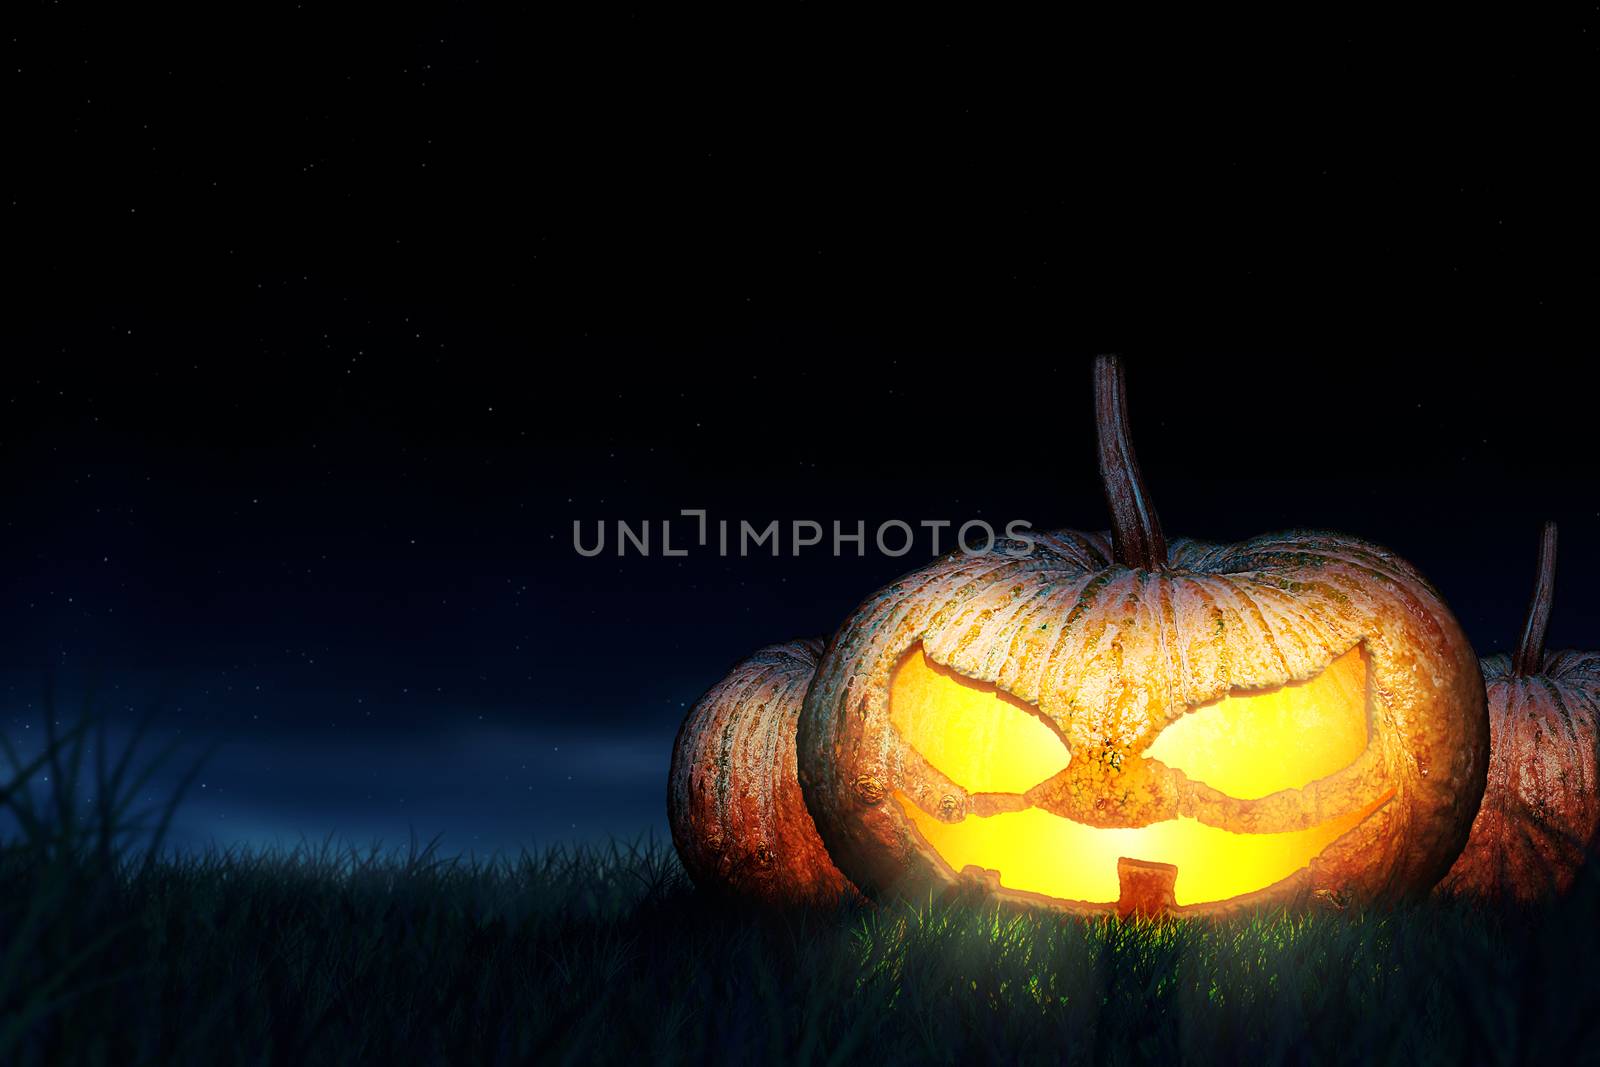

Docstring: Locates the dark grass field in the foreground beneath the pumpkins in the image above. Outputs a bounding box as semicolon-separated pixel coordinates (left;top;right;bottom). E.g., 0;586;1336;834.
0;713;1600;1067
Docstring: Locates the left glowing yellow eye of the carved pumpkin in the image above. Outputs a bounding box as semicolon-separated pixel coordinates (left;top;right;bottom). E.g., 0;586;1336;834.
890;645;1070;793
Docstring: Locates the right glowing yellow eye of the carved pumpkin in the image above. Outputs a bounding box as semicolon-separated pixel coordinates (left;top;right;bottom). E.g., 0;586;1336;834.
1144;646;1366;800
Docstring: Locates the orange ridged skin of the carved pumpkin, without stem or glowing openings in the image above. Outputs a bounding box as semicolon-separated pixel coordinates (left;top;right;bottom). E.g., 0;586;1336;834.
798;531;1490;913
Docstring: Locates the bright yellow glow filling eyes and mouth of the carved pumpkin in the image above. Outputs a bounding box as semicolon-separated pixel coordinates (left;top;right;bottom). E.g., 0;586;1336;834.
890;648;1387;905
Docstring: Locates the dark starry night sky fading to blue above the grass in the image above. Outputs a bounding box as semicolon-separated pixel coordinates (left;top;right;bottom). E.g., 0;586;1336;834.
0;5;1600;851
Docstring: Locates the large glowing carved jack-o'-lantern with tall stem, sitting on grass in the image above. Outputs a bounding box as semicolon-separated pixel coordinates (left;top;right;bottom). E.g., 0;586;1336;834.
798;357;1488;913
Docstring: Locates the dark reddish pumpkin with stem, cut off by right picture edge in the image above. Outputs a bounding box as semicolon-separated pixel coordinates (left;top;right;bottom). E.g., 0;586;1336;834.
1438;523;1600;902
